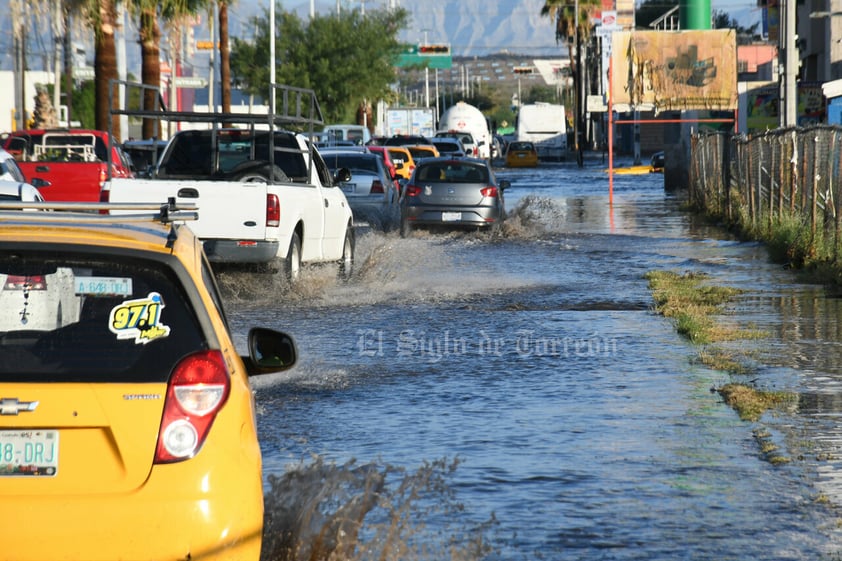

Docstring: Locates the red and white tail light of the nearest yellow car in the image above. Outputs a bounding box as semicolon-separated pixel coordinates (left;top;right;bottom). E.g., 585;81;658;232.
154;350;231;464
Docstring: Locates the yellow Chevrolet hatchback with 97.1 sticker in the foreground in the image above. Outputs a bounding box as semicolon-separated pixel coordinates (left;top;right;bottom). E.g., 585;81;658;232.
0;199;296;561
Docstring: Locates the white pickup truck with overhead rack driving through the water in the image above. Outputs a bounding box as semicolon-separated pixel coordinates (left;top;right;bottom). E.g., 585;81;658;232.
101;80;354;280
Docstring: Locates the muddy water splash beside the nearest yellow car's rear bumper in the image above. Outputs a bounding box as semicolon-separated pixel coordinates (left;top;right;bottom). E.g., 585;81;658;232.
261;457;496;561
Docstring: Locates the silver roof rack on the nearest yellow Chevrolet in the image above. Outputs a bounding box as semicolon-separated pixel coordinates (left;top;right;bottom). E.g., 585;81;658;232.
0;197;199;224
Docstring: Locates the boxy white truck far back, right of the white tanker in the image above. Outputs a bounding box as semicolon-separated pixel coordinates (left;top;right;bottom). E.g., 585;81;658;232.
515;101;567;161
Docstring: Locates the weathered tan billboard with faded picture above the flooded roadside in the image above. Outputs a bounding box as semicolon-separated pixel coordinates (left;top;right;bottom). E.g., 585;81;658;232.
611;29;738;112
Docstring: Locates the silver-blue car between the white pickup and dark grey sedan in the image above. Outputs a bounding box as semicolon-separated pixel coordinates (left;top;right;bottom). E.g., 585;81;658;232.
320;150;399;229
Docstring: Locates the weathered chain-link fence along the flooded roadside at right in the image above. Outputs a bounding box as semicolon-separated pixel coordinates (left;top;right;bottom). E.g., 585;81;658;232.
689;125;842;260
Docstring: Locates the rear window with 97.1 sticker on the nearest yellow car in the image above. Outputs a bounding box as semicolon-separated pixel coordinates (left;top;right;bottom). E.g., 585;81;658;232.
0;251;208;382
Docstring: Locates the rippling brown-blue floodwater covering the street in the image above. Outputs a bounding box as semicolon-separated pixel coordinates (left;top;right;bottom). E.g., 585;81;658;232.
221;155;842;561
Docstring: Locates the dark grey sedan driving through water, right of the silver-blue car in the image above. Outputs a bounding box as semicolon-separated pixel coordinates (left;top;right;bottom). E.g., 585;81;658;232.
401;158;509;237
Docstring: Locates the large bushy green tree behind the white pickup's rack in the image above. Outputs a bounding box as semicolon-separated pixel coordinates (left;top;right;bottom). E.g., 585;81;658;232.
231;9;408;122
